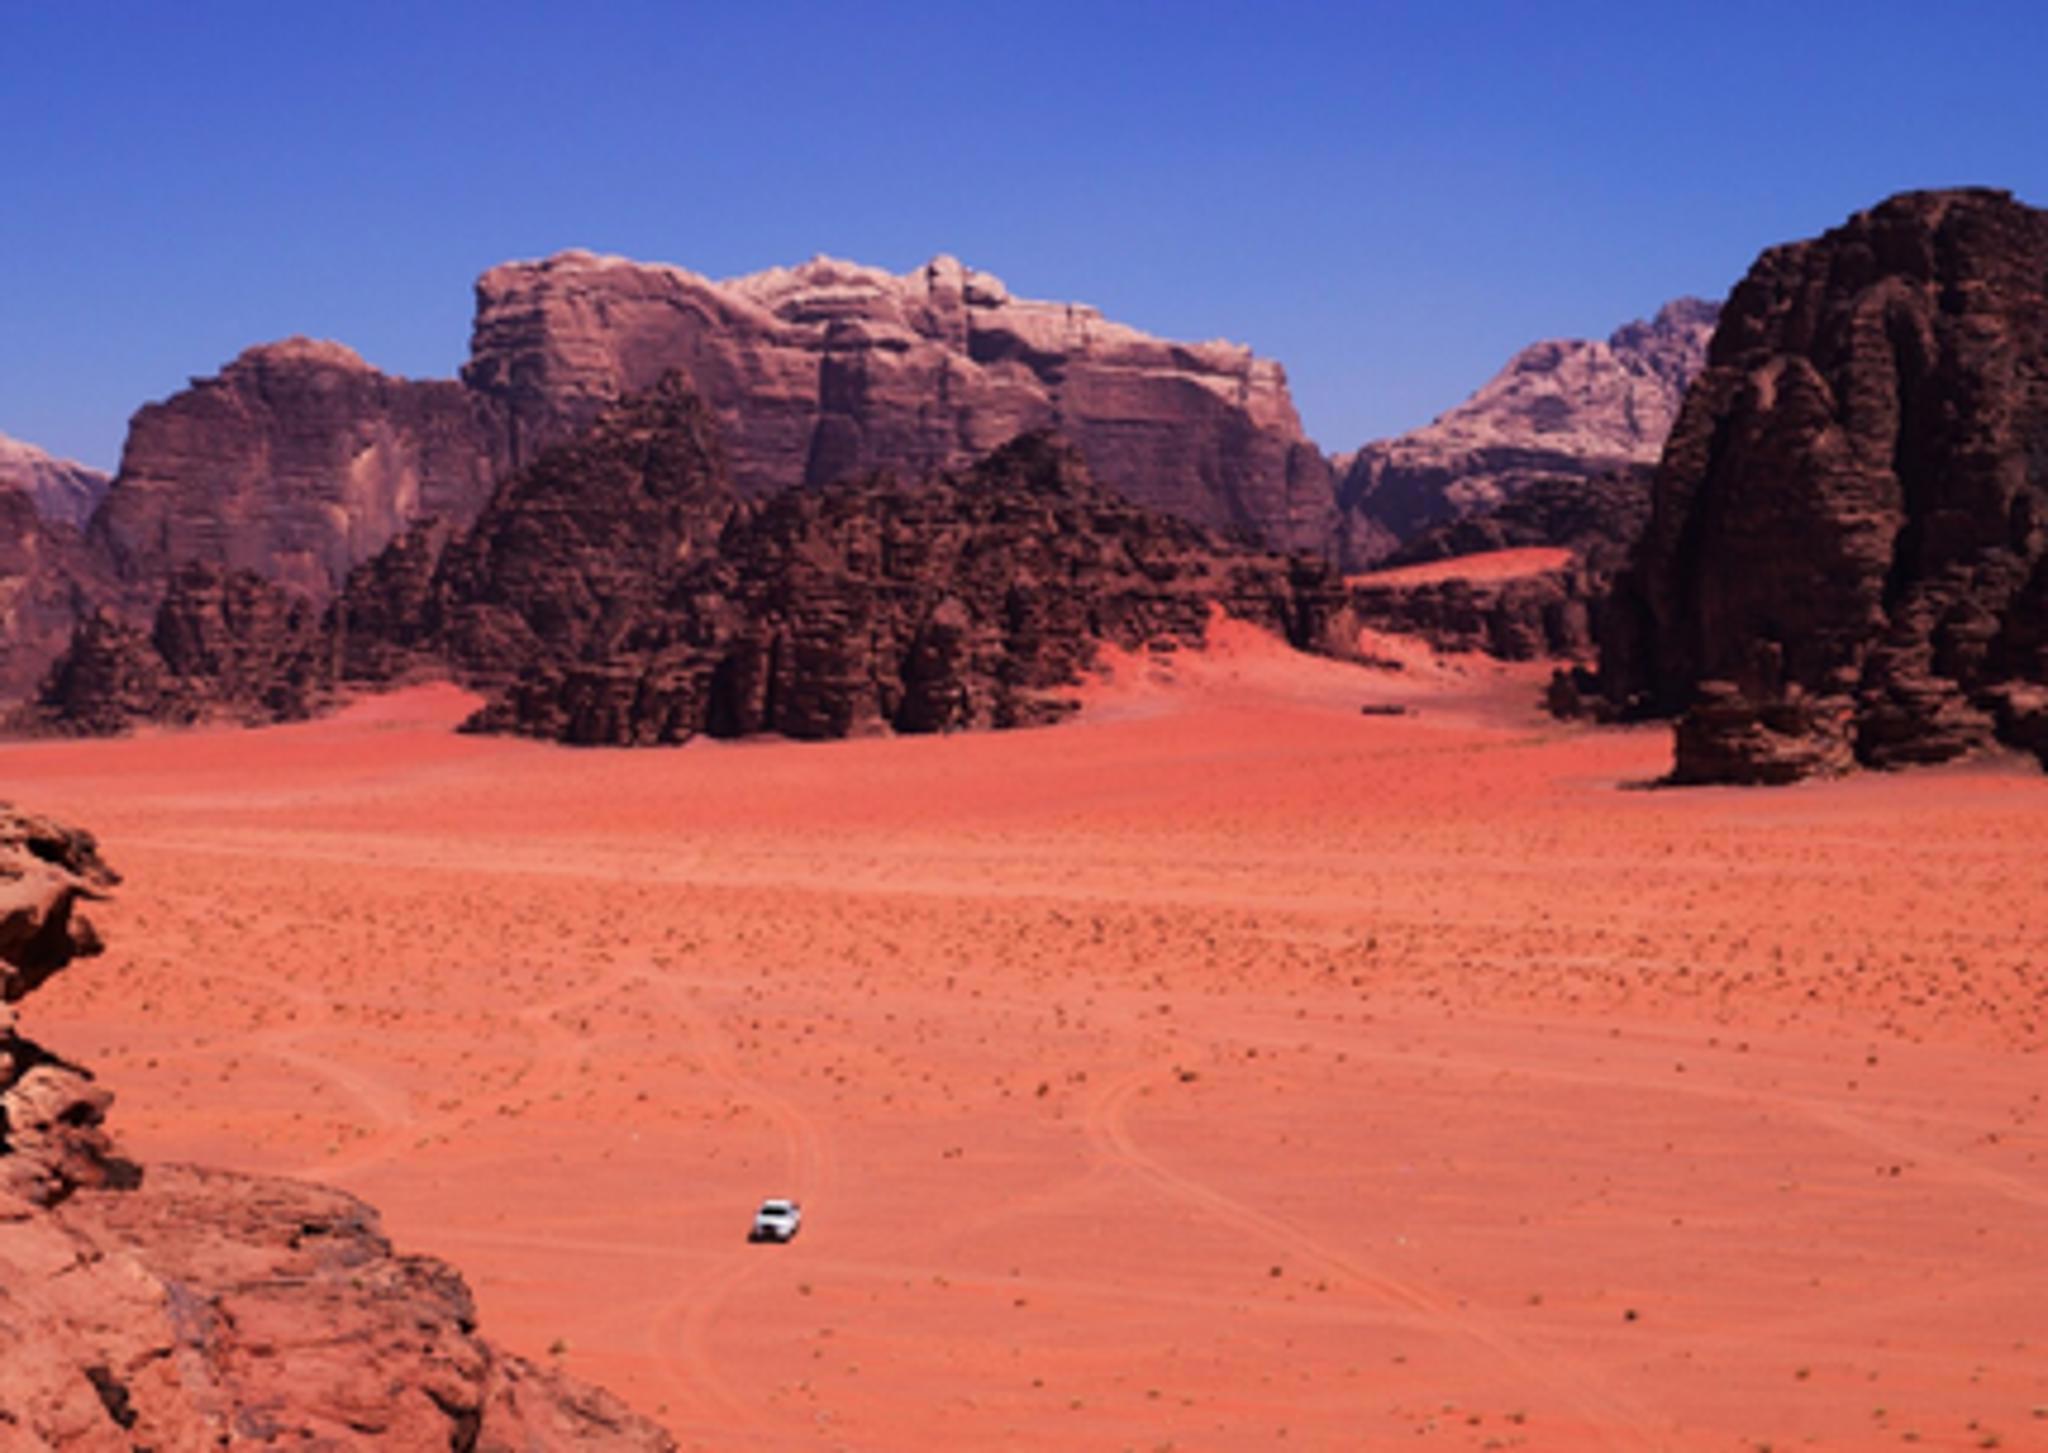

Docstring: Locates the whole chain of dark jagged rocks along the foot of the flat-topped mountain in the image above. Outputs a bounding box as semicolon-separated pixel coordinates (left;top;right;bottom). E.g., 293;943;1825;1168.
39;375;1356;744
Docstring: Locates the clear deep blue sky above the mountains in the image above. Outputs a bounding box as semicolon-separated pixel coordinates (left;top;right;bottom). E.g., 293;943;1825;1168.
0;0;2048;467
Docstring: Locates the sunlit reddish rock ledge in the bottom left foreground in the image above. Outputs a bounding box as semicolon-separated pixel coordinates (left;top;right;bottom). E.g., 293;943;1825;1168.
0;805;674;1453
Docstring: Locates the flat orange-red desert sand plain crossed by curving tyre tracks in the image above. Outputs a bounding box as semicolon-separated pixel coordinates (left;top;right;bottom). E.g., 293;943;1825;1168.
0;631;2048;1449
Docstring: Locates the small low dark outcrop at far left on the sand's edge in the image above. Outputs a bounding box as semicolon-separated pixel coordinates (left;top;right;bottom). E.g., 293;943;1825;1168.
10;562;336;736
